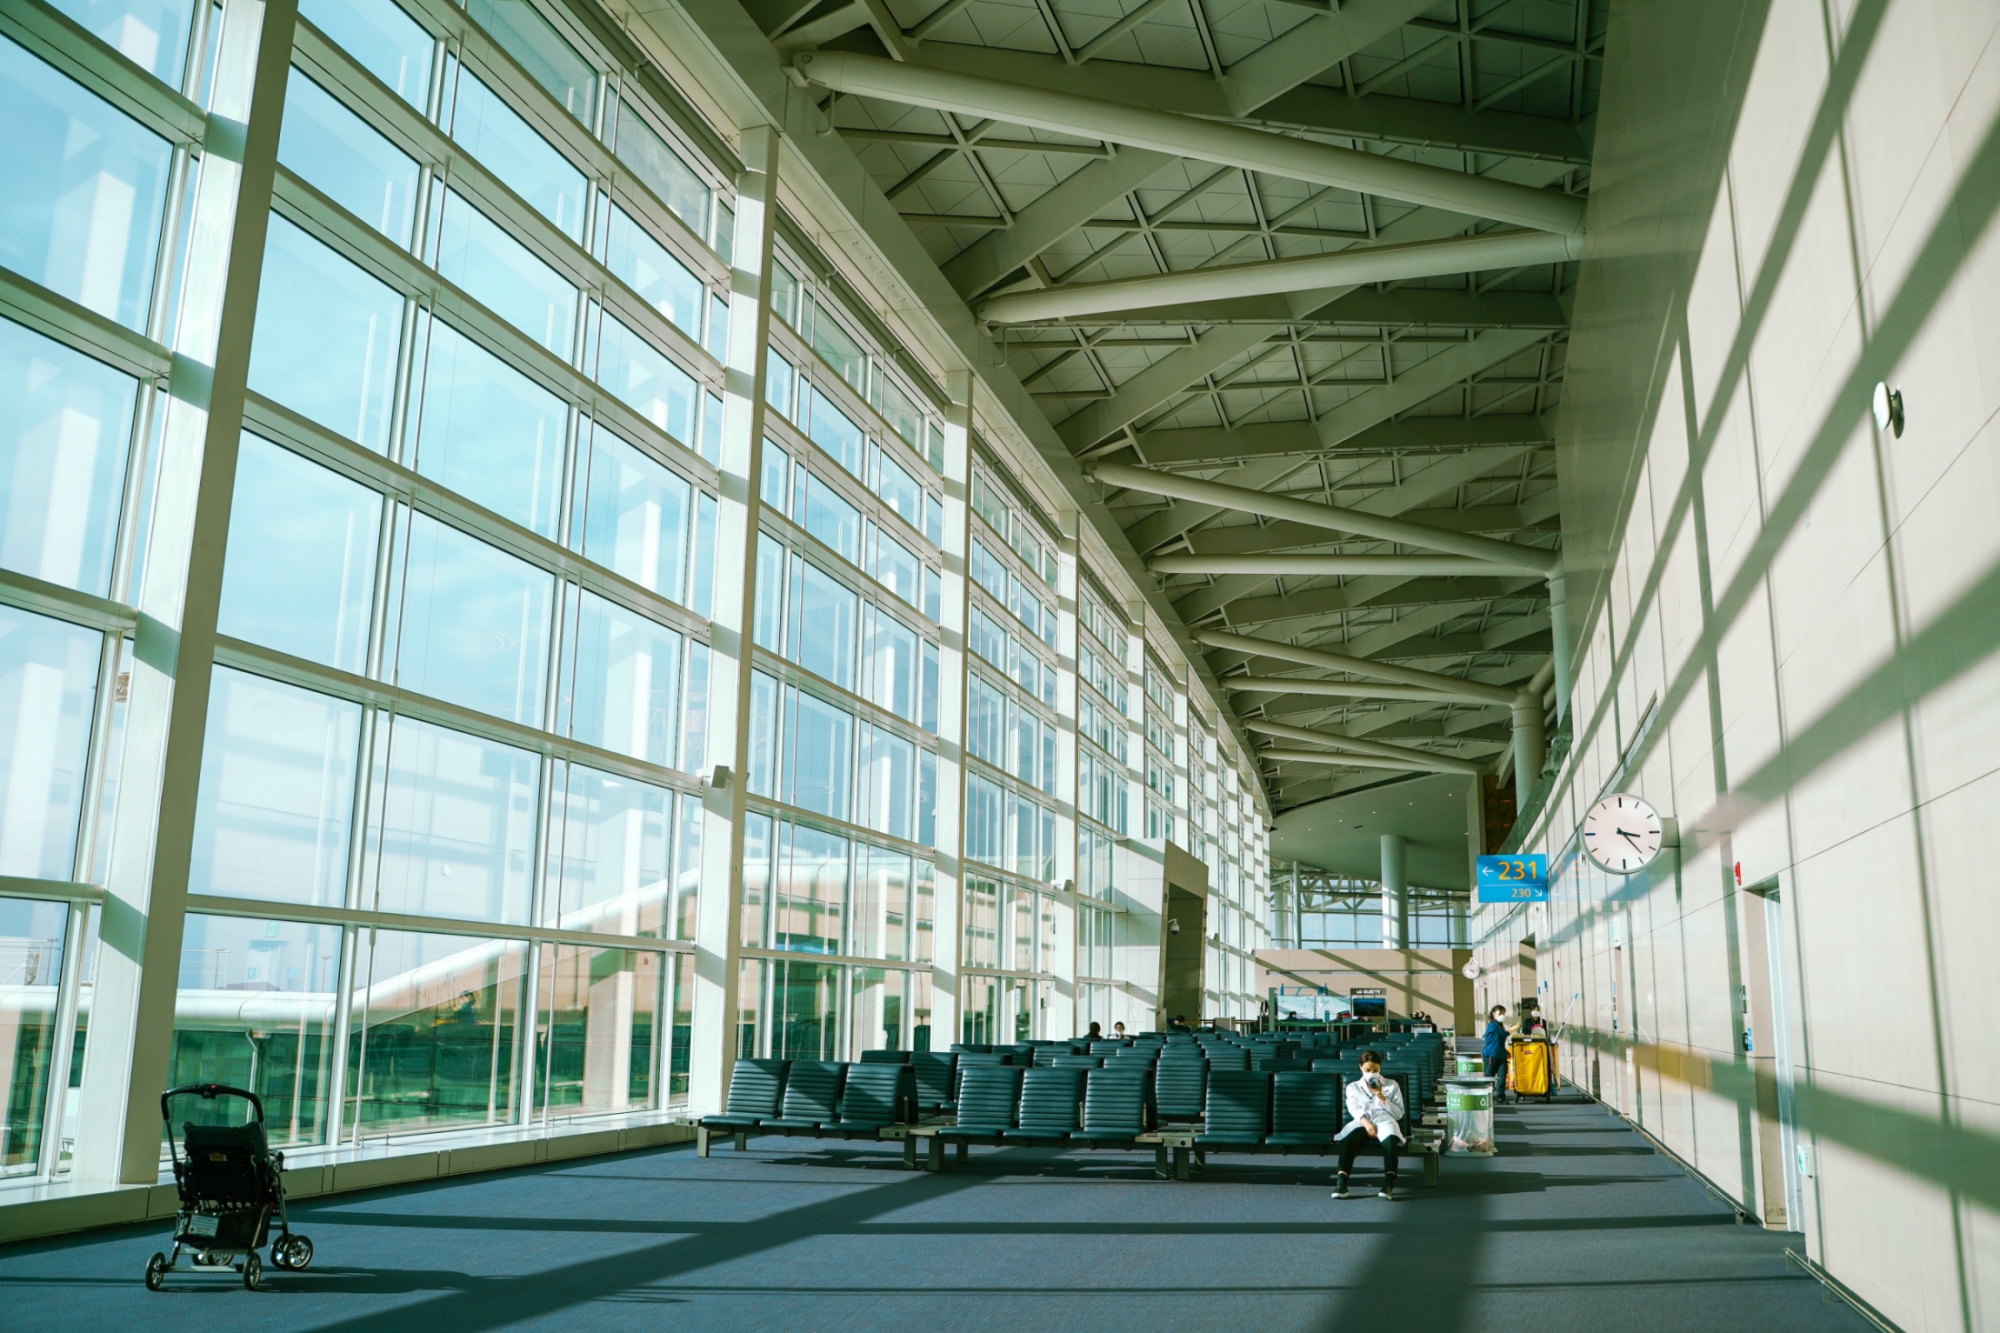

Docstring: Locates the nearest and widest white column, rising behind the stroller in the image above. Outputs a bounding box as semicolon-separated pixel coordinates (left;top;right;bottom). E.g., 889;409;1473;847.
74;0;298;1185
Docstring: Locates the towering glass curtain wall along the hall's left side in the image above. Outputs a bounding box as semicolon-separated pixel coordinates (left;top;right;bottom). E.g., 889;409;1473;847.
0;0;1262;1175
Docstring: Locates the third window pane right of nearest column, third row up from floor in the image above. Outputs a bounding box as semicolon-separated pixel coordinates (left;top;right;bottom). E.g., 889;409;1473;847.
556;592;680;767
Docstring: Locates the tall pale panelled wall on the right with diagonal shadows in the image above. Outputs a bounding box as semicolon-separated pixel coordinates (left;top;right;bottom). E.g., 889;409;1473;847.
1472;0;2000;1333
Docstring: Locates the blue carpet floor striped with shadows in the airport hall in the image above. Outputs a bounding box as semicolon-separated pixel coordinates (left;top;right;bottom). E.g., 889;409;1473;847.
0;1101;1866;1333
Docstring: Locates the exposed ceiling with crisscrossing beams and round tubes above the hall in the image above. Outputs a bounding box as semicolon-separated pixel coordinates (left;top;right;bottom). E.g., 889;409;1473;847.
746;0;1608;839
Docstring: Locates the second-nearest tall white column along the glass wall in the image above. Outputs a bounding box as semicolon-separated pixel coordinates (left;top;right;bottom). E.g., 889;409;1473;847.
688;126;780;1115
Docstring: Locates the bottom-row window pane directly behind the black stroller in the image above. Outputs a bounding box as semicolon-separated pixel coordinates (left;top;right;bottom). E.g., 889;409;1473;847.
166;915;340;1147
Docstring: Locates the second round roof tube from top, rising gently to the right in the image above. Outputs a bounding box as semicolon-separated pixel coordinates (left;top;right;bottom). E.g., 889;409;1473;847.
978;230;1584;324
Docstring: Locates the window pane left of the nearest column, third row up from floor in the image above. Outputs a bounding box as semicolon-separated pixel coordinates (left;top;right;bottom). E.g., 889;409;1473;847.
0;320;136;596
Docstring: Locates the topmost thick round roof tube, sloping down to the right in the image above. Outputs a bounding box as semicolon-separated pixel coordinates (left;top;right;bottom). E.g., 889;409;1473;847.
792;50;1584;236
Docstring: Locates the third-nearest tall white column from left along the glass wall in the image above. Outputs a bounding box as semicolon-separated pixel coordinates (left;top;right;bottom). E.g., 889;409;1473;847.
930;370;974;1051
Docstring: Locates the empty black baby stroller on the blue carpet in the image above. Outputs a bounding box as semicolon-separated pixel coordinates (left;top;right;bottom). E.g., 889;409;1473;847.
146;1083;312;1291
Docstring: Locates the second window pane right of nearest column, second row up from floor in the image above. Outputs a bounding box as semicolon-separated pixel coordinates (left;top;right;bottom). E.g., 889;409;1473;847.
362;717;538;925
